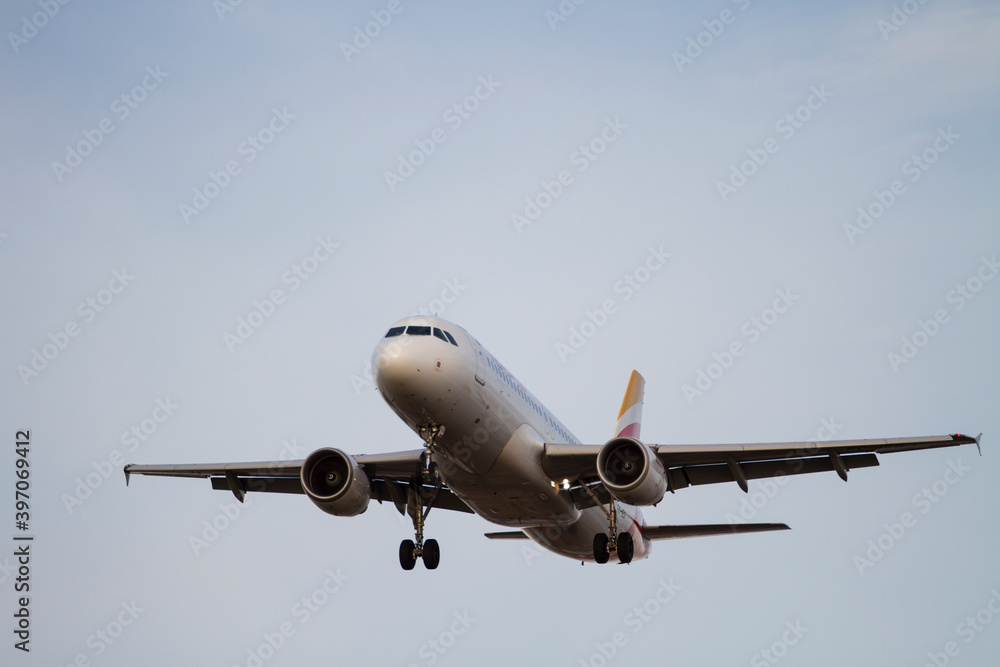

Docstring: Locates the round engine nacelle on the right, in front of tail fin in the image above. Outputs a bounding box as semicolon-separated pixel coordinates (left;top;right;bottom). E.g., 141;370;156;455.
597;438;667;505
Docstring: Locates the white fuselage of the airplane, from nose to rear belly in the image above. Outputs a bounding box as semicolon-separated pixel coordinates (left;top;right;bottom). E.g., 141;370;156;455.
372;317;650;560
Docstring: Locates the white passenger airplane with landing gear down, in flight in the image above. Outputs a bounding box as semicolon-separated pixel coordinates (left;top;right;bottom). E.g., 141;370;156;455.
125;316;982;570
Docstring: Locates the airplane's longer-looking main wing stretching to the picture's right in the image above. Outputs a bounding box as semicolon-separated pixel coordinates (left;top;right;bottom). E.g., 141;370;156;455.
542;433;982;508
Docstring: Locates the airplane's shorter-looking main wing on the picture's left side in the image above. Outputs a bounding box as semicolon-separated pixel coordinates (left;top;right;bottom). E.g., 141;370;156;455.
125;449;472;514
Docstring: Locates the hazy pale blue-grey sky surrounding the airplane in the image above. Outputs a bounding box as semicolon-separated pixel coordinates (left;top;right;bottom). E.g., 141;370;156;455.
0;0;1000;667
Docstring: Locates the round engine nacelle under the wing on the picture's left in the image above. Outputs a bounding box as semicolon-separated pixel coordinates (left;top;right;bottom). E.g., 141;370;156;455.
299;447;371;516
